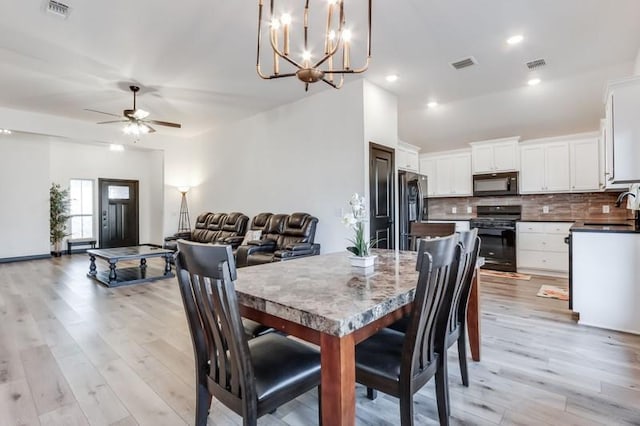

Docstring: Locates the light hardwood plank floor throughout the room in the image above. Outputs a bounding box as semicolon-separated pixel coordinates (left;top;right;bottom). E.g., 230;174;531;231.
0;254;640;426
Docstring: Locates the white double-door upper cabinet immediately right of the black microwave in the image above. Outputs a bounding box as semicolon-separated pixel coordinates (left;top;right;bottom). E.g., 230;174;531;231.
520;142;571;194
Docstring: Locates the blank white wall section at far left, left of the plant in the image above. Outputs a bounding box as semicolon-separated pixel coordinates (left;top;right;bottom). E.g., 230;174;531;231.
0;134;51;259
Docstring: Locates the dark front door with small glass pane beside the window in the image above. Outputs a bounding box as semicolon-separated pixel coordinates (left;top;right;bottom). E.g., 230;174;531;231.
98;179;139;248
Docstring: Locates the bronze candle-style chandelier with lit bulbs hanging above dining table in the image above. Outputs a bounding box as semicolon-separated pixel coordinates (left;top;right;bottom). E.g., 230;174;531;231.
256;0;371;91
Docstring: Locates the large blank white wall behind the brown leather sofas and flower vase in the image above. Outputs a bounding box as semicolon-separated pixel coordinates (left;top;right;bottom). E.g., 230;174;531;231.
192;81;365;253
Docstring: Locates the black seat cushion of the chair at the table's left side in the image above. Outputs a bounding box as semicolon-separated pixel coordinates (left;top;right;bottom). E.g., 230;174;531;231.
249;333;320;401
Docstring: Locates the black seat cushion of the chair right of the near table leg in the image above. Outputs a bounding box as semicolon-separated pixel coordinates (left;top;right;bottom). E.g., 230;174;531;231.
356;328;404;381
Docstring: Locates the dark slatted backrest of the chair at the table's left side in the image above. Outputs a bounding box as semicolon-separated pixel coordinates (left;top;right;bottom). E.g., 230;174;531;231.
176;241;256;400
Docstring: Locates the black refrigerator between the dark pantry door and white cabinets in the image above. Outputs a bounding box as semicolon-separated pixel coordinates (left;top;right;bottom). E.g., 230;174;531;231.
398;171;429;250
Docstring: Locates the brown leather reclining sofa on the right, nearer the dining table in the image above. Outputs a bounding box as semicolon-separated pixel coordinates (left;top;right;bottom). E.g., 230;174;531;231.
236;213;320;267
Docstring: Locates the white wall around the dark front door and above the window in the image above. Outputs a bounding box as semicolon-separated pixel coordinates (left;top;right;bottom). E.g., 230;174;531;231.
50;139;163;244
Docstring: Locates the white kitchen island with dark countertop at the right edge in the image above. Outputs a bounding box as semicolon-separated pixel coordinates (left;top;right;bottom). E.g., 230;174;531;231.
570;221;640;334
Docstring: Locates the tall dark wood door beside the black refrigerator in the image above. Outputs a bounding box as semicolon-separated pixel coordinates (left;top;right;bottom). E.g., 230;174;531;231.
369;143;395;249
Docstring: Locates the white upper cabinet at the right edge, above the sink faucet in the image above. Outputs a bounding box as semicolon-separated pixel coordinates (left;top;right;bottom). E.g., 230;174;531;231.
605;77;640;184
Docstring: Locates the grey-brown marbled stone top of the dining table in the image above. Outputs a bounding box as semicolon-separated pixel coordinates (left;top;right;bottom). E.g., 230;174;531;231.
236;250;418;337
